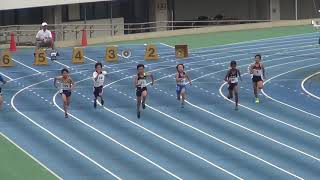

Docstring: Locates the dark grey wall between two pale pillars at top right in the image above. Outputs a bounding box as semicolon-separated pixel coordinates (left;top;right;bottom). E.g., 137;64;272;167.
175;0;269;20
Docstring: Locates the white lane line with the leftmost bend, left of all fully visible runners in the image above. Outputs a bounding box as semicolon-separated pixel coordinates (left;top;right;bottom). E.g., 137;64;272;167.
11;78;121;179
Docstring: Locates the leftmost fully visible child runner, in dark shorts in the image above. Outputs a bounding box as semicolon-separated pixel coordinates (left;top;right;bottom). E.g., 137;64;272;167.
54;69;75;118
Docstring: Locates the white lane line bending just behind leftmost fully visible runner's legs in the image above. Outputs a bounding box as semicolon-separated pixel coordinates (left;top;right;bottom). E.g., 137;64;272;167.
52;92;182;180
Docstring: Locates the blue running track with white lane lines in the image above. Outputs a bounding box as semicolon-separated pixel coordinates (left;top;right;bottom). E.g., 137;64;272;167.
0;33;320;180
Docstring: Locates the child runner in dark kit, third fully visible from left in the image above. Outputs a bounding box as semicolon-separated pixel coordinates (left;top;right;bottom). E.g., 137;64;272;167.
134;64;154;118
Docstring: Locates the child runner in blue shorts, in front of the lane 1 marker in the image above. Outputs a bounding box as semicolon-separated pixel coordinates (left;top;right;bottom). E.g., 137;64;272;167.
176;64;192;108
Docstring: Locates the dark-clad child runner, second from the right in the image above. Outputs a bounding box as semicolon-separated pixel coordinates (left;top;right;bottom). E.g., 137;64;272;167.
224;61;242;111
